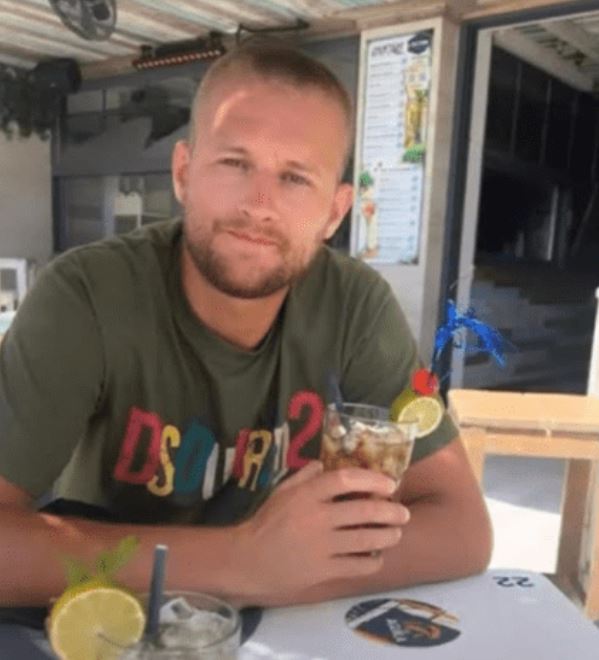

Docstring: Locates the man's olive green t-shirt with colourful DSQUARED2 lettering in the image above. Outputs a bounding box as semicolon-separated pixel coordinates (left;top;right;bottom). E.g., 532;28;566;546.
0;221;457;524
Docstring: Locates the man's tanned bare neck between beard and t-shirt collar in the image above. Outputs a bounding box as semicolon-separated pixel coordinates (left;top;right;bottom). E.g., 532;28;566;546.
181;246;289;350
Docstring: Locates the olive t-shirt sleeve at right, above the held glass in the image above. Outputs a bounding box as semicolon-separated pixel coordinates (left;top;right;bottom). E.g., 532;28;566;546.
341;281;458;462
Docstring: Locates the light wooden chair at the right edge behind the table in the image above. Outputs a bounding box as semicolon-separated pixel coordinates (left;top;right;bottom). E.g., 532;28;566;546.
448;389;599;619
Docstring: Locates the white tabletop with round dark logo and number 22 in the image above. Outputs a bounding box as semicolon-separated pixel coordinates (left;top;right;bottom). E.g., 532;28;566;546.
240;570;599;660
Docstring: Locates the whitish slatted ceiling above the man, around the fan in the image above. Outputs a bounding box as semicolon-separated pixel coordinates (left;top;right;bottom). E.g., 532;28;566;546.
0;0;436;72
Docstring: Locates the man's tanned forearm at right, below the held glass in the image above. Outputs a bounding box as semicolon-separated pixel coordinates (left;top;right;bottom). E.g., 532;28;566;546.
298;490;492;602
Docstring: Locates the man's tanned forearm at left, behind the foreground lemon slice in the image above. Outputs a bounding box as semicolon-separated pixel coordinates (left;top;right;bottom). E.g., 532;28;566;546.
0;505;251;605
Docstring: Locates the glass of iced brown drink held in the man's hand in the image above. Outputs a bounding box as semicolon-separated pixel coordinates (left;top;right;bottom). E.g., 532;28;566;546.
320;403;417;485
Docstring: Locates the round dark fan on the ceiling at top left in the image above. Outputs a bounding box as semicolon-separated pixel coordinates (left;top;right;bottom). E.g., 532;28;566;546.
50;0;116;41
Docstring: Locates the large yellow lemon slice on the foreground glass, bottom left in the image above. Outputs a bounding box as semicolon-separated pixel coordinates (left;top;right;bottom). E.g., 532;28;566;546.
48;583;146;660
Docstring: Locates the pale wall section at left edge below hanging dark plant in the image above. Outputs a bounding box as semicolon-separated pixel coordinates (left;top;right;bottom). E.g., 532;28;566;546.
0;132;52;267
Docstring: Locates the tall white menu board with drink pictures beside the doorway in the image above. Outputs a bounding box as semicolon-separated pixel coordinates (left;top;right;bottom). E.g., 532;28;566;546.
352;30;433;264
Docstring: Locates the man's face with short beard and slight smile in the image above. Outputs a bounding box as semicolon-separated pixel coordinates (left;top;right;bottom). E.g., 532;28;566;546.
173;74;351;298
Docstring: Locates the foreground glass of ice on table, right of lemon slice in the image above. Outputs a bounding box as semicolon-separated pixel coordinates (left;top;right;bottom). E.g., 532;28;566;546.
120;592;241;660
